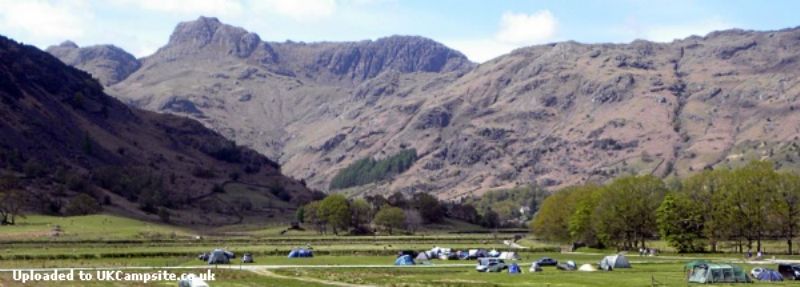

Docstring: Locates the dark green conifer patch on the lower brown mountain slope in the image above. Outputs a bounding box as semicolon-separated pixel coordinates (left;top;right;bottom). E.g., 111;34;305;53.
330;149;417;189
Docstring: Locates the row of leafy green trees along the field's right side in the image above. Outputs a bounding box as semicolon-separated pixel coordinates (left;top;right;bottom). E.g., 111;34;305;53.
530;161;800;254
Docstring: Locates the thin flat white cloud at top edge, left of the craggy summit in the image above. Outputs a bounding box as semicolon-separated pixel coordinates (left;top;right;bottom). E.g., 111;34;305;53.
110;0;244;16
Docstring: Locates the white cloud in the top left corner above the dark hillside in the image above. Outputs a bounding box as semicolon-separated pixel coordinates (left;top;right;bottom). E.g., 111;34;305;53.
0;0;94;45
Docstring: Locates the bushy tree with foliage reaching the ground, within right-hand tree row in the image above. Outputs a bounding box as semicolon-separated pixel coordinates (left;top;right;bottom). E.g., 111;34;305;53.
656;193;704;253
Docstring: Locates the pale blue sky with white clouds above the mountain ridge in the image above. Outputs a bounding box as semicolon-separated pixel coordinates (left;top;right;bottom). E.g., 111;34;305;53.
0;0;800;62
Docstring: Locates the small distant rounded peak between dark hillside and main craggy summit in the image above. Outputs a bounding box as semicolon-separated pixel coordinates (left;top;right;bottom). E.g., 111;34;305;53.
46;41;141;86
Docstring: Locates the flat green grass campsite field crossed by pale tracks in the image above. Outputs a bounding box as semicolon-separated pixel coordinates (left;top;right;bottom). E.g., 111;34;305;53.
0;215;800;286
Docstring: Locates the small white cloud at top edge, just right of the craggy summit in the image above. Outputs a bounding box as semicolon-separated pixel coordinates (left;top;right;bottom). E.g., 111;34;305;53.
252;0;337;22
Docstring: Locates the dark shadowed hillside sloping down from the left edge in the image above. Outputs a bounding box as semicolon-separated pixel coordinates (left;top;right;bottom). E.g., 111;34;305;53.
0;37;312;224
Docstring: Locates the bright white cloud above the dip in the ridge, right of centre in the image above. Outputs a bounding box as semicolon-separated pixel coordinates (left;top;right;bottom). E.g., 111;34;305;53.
444;10;558;63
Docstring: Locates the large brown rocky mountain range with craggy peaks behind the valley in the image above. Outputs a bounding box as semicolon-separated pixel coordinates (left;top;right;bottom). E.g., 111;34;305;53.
48;18;800;198
